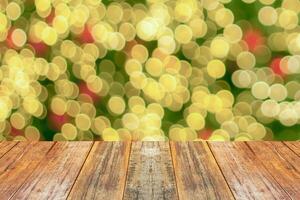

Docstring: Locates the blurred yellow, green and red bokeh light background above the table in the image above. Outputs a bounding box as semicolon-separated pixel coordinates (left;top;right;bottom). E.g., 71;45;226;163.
0;0;300;141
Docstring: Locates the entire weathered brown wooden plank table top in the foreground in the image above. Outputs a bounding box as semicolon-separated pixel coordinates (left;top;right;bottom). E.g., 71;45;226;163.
0;142;300;200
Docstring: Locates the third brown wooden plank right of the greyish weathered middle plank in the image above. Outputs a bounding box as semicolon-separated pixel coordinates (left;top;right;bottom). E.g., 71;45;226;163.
247;142;300;199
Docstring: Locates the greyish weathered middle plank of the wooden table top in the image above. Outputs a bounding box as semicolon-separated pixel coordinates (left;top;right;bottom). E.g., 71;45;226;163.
124;142;178;200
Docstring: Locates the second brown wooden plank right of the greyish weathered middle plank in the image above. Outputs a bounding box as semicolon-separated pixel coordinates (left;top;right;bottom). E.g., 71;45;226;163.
209;142;290;199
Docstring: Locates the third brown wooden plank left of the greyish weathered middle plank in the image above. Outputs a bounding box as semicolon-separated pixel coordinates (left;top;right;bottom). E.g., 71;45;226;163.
0;142;54;199
